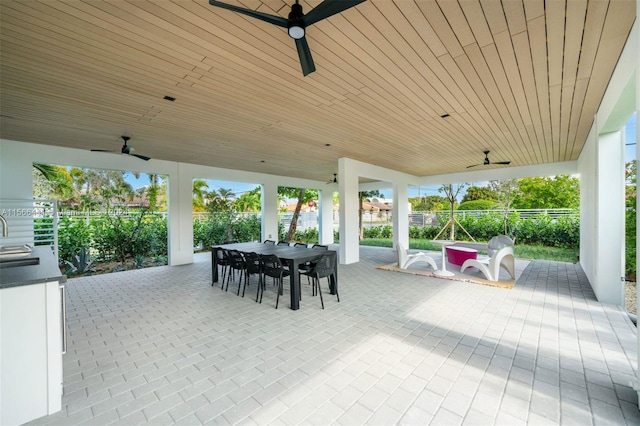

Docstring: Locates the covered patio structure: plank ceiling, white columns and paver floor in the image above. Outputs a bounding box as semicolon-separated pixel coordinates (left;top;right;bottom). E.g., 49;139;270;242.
0;0;640;424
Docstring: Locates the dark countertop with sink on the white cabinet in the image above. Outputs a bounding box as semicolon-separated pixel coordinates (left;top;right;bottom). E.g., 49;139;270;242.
0;246;67;290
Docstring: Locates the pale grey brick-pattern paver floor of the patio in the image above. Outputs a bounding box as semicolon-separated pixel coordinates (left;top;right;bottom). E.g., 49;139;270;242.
30;247;640;425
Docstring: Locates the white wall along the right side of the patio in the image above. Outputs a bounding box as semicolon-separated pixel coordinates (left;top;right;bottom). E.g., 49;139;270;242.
578;14;640;305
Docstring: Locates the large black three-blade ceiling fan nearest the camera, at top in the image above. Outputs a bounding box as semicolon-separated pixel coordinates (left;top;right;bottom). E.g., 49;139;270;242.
209;0;365;76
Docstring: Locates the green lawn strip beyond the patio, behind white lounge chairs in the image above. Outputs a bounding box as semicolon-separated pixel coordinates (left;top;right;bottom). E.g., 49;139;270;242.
360;238;578;263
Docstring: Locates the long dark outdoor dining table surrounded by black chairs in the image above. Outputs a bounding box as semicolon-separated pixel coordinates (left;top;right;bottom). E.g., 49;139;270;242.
211;242;338;310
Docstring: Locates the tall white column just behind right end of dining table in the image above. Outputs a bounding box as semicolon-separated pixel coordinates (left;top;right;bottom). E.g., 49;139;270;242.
338;158;360;265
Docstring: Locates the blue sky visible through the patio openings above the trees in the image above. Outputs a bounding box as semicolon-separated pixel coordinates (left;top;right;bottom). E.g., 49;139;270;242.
125;114;637;199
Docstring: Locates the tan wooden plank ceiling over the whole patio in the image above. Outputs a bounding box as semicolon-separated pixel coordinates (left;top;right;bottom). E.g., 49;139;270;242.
0;0;636;181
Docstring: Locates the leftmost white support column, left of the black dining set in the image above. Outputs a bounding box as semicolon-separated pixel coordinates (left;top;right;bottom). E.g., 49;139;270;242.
168;164;193;266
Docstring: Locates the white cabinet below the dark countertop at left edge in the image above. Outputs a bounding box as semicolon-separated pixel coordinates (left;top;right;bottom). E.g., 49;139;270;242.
0;281;62;426
